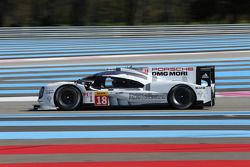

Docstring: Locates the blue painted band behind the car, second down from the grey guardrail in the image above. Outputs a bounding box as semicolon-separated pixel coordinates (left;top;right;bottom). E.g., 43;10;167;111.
1;42;249;52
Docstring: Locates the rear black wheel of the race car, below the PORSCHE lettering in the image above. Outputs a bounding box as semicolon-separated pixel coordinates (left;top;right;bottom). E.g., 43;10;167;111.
168;84;196;110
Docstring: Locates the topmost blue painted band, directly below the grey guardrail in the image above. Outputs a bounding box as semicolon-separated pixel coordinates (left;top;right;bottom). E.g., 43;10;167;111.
0;34;250;45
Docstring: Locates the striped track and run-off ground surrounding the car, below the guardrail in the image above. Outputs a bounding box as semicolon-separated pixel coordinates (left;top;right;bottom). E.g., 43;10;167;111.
0;26;250;167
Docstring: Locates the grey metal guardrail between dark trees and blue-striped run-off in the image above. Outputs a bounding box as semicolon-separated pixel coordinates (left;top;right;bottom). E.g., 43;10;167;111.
0;24;250;39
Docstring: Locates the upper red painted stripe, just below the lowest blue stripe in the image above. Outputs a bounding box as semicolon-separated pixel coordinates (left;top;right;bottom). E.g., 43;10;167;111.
0;144;250;154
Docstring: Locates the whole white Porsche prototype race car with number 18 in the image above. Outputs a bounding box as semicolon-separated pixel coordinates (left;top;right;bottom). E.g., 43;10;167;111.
34;66;215;110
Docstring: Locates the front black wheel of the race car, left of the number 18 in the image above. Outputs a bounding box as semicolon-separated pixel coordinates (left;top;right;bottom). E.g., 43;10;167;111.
54;85;82;110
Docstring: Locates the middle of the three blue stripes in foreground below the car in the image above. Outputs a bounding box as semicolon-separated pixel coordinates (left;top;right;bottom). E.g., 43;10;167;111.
0;119;250;126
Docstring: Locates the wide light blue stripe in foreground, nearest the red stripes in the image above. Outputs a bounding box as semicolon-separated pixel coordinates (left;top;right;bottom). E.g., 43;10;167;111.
0;130;250;140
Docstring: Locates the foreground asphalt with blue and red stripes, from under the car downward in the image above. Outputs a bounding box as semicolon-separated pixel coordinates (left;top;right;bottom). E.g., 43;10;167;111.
0;97;250;166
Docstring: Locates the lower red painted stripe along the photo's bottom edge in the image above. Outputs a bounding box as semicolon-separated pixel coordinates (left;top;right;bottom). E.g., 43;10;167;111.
0;160;250;167
